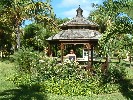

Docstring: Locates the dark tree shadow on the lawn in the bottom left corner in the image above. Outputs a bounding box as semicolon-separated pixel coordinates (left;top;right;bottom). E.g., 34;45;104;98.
0;86;47;100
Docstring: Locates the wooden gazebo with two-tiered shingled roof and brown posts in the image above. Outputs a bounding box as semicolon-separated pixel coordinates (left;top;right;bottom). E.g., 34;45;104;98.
47;6;101;66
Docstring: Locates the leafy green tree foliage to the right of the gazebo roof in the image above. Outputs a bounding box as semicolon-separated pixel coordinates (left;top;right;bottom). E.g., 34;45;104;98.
89;0;133;58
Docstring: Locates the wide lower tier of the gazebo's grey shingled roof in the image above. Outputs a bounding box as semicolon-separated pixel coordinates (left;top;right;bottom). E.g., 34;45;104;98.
48;29;101;40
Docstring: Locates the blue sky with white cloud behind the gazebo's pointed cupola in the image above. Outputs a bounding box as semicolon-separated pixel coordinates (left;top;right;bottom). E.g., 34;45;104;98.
51;0;104;18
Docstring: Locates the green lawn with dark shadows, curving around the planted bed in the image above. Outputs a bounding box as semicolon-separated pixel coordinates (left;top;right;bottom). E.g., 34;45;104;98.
0;61;133;100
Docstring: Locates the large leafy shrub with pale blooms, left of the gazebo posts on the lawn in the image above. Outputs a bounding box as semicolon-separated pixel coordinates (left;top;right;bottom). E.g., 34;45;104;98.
13;47;57;85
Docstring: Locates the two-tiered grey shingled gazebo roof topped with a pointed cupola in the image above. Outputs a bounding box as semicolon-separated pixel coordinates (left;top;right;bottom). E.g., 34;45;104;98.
47;6;101;41
